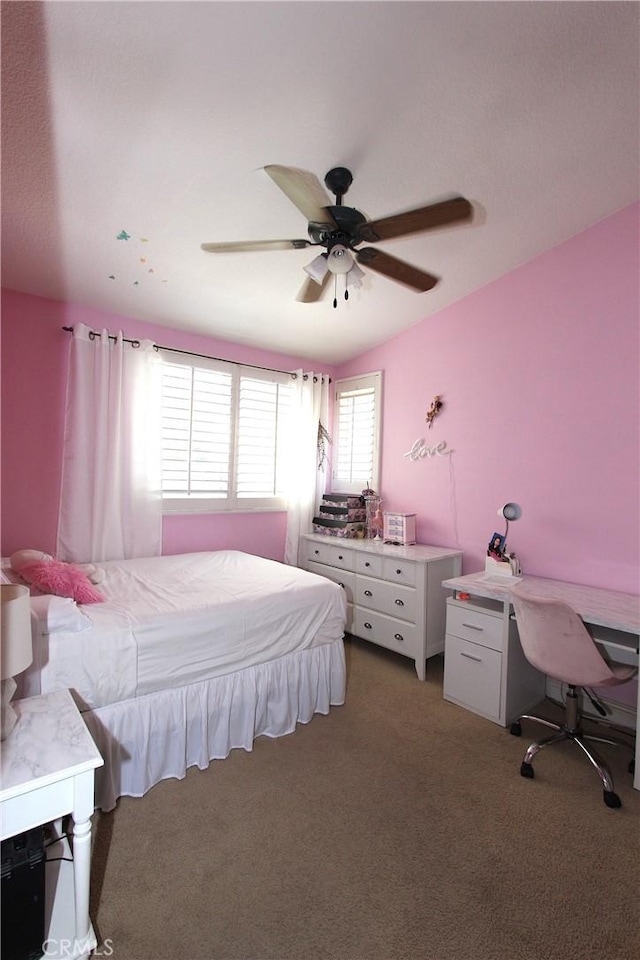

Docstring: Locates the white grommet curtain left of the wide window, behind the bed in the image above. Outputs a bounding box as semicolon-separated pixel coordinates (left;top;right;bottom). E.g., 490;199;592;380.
57;323;162;563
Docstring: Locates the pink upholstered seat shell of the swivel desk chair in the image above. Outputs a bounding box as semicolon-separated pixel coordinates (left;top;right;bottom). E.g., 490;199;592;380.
511;587;620;687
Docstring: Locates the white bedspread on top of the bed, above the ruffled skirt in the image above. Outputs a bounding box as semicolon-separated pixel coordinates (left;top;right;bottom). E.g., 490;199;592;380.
25;551;346;708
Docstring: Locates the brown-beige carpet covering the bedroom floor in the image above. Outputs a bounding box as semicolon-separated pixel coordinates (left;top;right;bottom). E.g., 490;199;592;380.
92;640;640;960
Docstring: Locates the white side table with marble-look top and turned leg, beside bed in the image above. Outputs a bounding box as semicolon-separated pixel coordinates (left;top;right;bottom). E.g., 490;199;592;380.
0;690;104;960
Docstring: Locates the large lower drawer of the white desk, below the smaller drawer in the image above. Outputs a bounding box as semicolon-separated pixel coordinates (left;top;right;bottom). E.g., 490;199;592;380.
442;634;502;723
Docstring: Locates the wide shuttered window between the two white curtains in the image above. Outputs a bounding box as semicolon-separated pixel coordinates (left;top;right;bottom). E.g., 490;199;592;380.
162;357;292;513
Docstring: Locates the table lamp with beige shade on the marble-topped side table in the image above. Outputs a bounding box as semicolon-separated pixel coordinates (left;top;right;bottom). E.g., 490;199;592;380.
0;583;33;740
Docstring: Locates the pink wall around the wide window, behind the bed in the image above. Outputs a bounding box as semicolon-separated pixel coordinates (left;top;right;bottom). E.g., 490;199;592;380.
1;290;333;560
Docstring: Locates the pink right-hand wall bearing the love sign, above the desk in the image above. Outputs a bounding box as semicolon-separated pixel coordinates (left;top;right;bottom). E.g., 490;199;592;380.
337;205;640;593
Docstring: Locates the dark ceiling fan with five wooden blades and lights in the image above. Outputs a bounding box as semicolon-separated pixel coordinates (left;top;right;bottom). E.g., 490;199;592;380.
201;164;473;307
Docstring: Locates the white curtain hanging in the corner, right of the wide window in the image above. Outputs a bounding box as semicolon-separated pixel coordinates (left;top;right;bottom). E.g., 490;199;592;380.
284;370;329;566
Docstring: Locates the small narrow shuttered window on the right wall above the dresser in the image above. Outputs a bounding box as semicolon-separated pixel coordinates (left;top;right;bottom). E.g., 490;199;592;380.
332;371;382;493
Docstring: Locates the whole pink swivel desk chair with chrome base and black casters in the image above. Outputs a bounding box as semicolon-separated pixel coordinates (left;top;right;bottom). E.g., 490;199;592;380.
511;587;637;807
